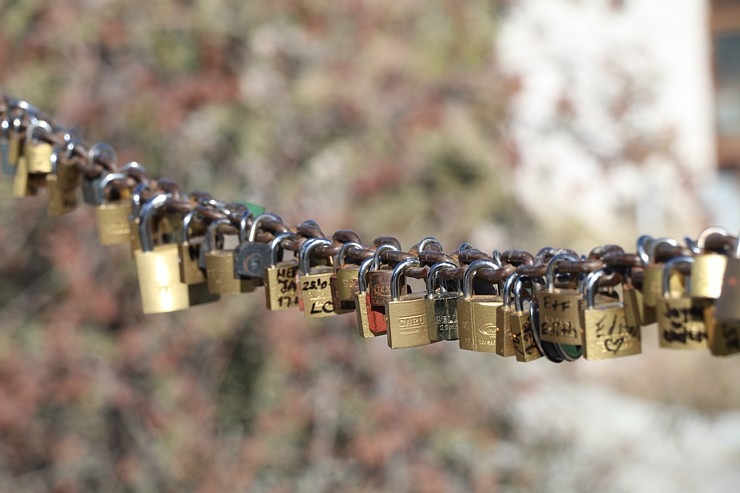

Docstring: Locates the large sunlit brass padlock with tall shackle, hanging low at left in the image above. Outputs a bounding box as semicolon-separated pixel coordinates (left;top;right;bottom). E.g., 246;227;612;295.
134;195;190;314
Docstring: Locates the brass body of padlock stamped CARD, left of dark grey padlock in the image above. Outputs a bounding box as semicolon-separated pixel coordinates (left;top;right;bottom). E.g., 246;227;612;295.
386;293;431;349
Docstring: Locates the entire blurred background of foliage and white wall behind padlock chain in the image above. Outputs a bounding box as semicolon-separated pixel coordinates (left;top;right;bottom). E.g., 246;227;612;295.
0;0;740;493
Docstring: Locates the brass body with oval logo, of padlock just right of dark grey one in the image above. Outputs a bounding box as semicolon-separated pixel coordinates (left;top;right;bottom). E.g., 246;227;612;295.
457;295;503;353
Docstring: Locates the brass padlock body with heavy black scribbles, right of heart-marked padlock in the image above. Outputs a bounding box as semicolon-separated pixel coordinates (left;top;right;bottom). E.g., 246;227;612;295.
655;297;707;349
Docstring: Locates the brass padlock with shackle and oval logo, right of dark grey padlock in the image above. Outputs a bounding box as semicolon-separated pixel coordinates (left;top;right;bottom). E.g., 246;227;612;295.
457;259;503;353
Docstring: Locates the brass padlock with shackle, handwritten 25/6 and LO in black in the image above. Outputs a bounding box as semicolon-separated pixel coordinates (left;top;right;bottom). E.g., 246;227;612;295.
298;238;336;318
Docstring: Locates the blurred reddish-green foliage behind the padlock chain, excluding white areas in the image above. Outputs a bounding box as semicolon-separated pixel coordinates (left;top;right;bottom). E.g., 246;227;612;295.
0;0;740;493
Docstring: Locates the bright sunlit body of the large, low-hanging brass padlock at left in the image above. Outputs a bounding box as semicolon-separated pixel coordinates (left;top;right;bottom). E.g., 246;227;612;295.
134;244;190;314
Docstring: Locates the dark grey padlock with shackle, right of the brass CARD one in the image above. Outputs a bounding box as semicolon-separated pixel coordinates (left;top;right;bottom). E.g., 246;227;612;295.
424;262;460;342
